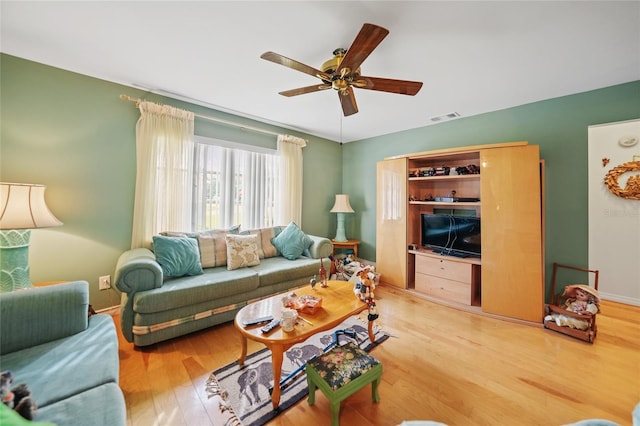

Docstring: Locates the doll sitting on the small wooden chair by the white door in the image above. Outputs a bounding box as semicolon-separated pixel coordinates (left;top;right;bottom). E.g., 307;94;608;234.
544;284;600;330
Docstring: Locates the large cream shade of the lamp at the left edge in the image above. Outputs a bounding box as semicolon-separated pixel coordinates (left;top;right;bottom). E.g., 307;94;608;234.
0;182;62;229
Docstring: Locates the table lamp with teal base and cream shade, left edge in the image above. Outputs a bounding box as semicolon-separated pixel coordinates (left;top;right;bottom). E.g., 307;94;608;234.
0;182;62;292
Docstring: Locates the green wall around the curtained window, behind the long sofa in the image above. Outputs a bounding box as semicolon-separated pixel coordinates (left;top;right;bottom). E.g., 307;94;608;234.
0;54;342;309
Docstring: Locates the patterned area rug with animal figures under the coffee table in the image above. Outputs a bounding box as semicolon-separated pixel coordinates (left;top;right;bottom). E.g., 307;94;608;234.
206;316;389;426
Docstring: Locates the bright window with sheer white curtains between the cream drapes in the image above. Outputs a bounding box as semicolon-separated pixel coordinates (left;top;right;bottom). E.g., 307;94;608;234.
192;137;280;231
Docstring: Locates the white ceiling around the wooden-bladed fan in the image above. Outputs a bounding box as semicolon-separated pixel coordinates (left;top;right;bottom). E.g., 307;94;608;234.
0;0;640;142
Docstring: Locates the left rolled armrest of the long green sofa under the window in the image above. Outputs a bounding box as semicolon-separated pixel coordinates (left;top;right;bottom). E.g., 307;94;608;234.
114;248;163;293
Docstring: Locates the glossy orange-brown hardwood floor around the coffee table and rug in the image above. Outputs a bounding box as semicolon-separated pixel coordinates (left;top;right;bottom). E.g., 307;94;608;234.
114;286;640;426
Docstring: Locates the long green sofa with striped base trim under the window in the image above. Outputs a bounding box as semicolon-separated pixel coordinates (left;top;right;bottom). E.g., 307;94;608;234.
114;224;333;346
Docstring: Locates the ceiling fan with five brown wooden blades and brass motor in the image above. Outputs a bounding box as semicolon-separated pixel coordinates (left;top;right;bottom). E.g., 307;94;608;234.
260;24;422;116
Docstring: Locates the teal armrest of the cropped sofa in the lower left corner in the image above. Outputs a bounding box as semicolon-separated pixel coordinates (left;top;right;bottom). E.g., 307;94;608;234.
0;281;89;354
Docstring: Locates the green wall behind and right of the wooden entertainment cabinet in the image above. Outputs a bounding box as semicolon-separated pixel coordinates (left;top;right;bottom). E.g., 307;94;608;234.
342;81;640;300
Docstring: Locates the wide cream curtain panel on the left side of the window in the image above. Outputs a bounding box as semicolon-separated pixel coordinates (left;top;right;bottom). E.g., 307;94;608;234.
131;102;194;248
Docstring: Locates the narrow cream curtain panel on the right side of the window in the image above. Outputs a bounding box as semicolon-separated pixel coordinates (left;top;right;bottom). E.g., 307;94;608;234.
276;135;307;227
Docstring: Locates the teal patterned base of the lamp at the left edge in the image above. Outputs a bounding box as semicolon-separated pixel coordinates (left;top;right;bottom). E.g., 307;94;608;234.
0;229;33;293
